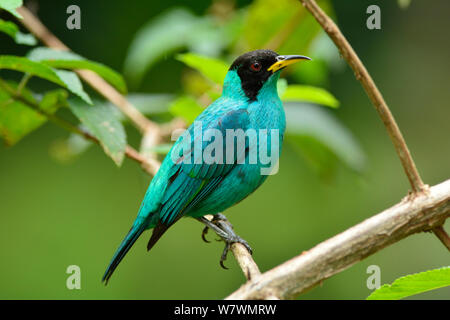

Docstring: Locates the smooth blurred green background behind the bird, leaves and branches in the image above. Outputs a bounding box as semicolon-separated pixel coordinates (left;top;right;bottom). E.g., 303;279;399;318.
0;0;450;299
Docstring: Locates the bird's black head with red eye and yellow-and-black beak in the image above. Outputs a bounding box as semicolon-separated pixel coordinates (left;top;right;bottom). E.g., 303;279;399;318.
230;50;311;100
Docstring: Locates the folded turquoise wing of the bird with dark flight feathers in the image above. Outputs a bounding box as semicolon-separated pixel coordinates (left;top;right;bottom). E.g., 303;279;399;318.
147;109;250;249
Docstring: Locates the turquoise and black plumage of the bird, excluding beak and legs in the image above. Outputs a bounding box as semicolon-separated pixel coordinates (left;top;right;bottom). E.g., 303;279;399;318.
103;50;310;282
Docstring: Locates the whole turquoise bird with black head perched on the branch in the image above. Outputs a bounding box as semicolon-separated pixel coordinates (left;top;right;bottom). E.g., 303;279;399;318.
102;50;310;283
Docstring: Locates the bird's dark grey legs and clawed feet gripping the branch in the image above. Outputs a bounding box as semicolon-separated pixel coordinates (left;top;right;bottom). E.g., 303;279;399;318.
197;213;253;269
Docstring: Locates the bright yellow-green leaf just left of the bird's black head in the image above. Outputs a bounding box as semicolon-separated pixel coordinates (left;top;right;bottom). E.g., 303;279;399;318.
176;53;228;85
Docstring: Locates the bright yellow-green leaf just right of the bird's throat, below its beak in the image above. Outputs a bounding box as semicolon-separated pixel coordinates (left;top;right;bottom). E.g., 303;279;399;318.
281;85;339;108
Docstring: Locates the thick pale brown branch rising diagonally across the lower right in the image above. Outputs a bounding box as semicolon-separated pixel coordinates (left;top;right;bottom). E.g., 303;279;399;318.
227;180;450;299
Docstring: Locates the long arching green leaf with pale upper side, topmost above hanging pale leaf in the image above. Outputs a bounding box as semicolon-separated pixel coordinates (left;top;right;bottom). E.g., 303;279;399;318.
27;47;127;93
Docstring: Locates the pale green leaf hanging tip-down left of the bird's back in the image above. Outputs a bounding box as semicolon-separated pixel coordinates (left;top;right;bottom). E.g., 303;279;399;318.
69;99;127;166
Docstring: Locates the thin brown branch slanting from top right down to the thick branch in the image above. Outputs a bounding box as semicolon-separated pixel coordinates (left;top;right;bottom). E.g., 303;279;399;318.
300;0;426;192
